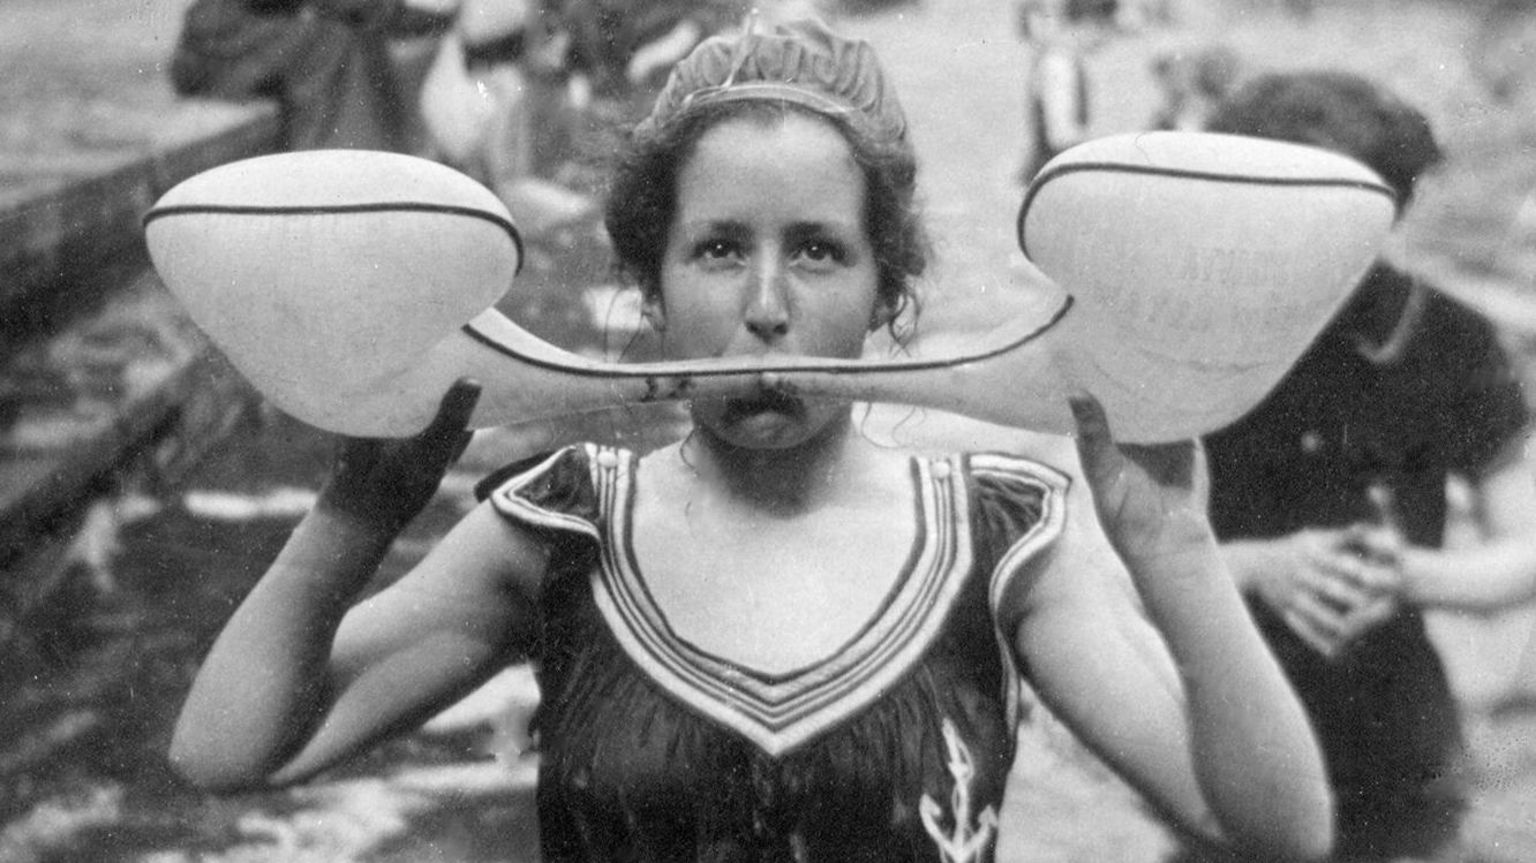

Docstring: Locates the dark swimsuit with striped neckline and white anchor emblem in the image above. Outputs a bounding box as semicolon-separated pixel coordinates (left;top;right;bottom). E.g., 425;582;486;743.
488;445;1066;863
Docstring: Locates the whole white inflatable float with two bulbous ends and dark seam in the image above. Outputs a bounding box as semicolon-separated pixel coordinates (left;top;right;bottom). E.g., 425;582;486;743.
144;132;1395;442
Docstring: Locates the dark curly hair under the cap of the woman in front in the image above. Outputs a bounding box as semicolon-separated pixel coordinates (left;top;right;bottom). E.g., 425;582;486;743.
604;100;929;339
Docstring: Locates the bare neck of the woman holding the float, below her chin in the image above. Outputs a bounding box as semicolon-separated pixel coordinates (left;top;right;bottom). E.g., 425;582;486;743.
680;408;859;516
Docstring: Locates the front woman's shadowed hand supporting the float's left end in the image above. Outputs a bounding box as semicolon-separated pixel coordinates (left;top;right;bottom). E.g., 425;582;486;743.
318;379;481;536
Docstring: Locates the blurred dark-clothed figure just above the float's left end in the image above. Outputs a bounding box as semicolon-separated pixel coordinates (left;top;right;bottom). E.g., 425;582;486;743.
170;0;456;152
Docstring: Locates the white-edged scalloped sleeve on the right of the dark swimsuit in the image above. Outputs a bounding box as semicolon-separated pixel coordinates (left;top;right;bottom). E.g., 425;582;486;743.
969;453;1071;640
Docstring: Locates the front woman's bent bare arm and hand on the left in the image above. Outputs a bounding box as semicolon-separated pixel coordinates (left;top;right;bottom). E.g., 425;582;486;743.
170;380;544;789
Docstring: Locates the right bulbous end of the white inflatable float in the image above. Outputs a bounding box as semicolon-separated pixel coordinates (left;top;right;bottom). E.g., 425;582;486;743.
1018;132;1396;439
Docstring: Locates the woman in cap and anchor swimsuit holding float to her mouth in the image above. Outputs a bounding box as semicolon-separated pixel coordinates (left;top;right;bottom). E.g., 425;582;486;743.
172;23;1330;861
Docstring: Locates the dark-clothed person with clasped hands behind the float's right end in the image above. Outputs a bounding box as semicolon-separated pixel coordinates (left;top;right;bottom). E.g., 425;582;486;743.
1206;72;1536;860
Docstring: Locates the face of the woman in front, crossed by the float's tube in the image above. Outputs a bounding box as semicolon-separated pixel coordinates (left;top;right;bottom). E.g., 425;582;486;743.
653;112;882;447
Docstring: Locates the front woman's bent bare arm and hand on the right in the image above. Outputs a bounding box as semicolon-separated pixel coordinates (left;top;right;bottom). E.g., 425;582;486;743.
1017;405;1332;860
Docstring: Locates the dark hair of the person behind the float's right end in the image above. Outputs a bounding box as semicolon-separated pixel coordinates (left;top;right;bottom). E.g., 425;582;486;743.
1206;71;1445;210
